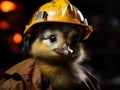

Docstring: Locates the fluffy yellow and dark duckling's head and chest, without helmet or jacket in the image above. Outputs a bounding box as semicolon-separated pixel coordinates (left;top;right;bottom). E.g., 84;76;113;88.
30;24;99;90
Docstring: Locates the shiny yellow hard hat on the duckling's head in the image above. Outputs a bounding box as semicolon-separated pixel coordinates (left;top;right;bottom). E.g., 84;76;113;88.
24;0;93;39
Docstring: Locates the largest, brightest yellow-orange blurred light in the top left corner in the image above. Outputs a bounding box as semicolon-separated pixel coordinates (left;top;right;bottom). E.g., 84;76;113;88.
0;1;16;12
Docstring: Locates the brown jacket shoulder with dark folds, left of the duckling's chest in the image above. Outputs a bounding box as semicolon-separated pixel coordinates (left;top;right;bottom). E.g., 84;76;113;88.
0;58;40;90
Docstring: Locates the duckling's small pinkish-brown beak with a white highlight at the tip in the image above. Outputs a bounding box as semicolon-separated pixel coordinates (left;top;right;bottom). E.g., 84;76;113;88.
55;43;73;56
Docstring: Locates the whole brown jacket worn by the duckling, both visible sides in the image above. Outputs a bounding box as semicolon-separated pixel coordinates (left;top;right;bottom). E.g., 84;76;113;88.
0;58;99;90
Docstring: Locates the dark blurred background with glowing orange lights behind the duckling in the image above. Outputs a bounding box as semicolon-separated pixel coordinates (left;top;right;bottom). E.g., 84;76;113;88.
0;0;120;90
